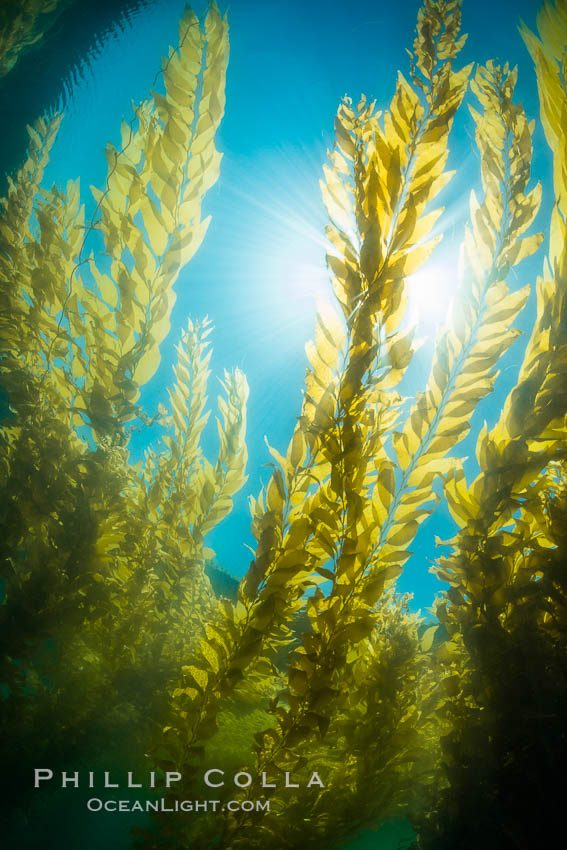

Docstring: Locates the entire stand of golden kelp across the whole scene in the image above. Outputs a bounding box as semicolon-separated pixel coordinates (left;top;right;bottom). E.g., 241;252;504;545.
0;0;567;850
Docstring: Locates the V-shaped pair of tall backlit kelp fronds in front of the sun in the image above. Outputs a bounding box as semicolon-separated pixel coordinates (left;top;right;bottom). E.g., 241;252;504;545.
216;11;542;846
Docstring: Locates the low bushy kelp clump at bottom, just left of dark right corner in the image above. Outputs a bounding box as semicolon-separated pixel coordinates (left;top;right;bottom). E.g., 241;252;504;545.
217;593;431;850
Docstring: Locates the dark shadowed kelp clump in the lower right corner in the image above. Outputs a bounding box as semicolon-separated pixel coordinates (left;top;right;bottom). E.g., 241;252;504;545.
424;464;567;850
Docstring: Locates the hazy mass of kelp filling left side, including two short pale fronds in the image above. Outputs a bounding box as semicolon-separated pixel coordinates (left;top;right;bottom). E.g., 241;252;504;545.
0;0;248;828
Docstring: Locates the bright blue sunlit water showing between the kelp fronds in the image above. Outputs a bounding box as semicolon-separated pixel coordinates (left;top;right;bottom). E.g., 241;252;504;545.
38;0;552;609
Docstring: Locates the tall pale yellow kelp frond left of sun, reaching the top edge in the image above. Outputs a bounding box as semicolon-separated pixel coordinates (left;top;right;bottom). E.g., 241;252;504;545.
87;6;228;398
